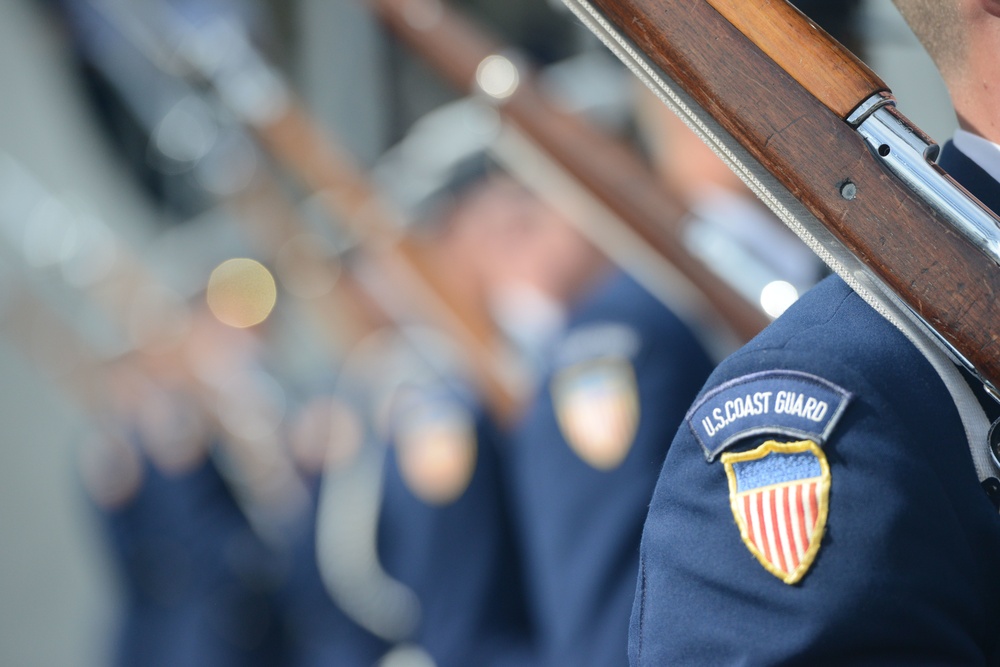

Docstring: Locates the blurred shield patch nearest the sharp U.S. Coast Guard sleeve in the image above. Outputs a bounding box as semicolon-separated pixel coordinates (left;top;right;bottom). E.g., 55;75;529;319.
552;357;639;470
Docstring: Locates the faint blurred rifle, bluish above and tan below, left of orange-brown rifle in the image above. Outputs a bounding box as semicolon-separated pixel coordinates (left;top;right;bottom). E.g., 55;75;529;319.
59;0;398;352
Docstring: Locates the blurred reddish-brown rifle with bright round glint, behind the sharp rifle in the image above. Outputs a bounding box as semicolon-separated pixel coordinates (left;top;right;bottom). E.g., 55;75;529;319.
369;0;769;341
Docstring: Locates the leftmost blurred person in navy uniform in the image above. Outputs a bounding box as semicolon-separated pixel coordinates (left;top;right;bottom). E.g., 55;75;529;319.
83;302;287;667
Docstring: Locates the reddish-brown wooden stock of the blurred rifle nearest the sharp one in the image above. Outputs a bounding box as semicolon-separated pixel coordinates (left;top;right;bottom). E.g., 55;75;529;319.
370;0;769;341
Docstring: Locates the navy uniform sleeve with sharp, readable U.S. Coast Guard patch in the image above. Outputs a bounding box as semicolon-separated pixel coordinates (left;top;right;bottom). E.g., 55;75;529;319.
630;68;1000;665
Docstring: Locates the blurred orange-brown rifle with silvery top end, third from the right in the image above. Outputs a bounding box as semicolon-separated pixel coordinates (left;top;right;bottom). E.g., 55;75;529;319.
80;0;523;421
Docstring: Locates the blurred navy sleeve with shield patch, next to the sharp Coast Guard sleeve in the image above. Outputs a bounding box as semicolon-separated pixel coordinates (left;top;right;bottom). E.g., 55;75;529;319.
513;310;710;667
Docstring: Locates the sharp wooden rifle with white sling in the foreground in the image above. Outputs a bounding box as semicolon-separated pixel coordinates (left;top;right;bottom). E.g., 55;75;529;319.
565;0;1000;399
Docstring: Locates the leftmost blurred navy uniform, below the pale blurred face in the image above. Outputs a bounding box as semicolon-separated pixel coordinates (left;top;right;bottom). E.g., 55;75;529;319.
104;434;285;667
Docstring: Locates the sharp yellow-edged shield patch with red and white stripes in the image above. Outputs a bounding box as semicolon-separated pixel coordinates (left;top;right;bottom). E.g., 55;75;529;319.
722;440;830;584
